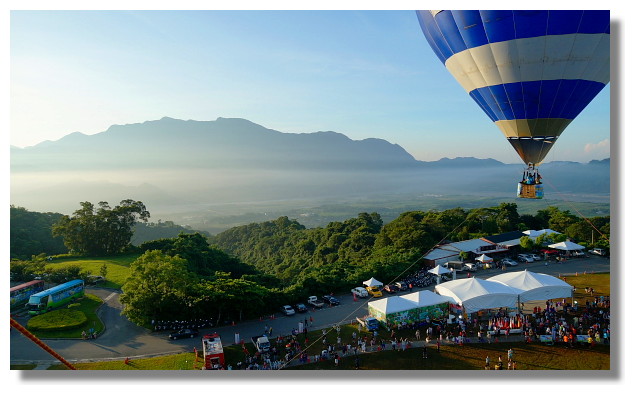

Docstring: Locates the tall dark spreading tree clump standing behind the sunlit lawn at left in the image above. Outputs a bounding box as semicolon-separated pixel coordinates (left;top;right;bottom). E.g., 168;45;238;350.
53;199;150;255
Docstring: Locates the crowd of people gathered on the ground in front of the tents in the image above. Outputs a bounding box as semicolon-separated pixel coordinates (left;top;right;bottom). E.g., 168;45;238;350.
224;271;611;370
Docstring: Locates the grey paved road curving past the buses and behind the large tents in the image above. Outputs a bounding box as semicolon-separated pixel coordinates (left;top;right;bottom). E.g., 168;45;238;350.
10;257;610;364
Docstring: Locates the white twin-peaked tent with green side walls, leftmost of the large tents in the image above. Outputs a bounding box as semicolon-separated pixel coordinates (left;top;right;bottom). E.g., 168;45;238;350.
368;291;452;327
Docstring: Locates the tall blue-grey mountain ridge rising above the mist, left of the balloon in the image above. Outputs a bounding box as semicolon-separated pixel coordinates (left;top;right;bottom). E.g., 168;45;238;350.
11;118;418;172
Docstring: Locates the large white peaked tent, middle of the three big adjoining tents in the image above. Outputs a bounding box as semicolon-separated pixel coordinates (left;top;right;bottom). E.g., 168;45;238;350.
434;277;522;313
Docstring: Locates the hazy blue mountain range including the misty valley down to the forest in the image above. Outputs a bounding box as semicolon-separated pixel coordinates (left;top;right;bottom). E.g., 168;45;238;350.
11;118;610;224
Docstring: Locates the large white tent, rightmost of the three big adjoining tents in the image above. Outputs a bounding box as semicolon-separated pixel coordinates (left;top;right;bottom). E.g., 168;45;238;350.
487;270;573;302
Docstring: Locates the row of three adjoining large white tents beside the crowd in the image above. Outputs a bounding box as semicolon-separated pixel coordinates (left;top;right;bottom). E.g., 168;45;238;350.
368;270;573;325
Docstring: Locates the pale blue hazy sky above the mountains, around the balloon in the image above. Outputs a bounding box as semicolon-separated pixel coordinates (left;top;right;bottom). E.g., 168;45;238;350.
10;6;611;163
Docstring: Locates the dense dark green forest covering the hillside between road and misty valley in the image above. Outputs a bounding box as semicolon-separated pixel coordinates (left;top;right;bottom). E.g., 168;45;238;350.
11;202;610;324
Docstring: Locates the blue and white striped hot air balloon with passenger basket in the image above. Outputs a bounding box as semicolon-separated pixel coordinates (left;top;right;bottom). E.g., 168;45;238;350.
417;10;610;198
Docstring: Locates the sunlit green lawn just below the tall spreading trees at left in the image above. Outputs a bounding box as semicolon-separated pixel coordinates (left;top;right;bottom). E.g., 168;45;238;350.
47;254;139;289
